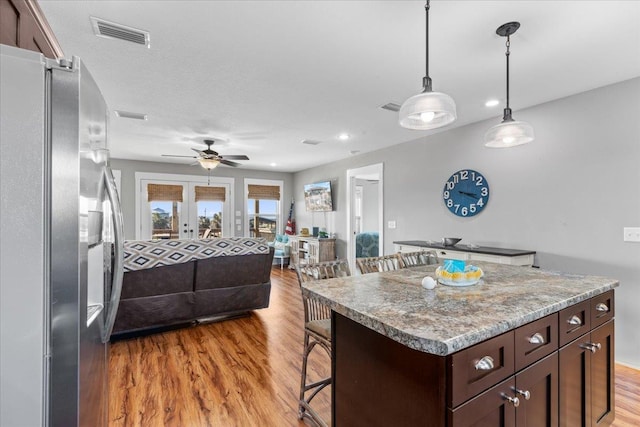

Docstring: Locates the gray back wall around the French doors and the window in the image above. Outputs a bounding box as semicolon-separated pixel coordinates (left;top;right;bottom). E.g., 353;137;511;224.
111;159;293;239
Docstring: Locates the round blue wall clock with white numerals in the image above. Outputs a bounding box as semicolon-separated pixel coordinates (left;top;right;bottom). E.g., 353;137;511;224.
442;169;489;217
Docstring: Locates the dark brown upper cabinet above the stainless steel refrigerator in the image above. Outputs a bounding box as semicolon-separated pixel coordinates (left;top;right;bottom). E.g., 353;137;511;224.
0;0;62;58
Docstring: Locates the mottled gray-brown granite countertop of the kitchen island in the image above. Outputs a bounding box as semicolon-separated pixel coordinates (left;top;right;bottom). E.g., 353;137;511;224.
303;262;619;356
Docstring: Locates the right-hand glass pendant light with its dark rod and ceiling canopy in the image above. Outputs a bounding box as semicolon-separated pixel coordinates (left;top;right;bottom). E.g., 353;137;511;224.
484;22;534;148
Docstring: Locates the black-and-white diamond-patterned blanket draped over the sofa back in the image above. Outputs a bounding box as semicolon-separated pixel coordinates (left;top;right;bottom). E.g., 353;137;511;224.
124;237;269;271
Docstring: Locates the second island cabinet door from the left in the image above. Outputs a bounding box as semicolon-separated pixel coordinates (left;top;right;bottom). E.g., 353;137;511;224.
512;352;558;427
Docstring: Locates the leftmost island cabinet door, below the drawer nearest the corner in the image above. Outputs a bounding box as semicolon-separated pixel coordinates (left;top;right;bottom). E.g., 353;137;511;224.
447;377;516;427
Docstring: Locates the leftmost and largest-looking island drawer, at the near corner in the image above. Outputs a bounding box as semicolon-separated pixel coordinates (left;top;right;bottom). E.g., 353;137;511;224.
447;331;515;408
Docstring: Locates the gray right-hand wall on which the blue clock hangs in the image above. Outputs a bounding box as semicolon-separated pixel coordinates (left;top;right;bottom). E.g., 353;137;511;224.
293;78;640;367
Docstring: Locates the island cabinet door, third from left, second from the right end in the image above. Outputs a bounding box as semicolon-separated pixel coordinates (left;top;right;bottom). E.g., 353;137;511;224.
558;334;591;427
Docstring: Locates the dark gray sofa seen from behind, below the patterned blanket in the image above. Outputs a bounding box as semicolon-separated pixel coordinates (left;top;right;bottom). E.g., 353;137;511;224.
112;239;274;337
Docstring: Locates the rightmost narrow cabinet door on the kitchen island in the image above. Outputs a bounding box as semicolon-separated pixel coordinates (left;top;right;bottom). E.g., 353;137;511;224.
590;320;615;427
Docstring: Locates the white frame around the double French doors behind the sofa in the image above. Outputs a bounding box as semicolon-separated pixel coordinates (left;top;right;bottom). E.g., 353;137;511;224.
135;172;235;240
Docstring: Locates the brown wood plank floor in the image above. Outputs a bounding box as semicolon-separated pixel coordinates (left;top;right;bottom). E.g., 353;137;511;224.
109;268;640;427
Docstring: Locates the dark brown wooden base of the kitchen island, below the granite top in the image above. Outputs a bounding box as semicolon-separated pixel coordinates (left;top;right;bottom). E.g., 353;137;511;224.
332;291;615;427
